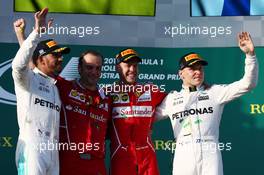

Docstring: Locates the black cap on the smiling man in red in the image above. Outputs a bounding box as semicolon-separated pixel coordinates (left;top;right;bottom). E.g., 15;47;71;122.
116;49;142;64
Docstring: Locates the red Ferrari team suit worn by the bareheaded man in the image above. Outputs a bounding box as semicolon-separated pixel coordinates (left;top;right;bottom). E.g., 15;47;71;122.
57;77;111;175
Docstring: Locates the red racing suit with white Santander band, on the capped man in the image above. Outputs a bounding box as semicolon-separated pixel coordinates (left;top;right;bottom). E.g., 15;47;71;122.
110;84;165;175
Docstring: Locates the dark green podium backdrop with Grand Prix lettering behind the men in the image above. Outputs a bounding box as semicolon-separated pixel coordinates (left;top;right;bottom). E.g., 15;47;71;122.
0;43;264;175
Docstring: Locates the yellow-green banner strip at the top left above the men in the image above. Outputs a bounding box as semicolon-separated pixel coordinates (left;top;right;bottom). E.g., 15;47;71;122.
14;0;155;16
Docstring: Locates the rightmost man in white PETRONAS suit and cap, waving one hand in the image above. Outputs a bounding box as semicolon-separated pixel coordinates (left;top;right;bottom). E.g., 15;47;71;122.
156;32;258;175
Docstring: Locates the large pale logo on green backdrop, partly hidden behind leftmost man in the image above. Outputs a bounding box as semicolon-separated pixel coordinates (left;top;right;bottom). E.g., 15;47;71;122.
0;57;79;105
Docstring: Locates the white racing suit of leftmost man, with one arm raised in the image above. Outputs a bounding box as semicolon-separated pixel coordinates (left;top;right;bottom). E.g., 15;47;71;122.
12;31;61;175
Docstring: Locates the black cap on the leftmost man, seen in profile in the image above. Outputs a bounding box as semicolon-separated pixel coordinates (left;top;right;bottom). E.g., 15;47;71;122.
33;39;70;61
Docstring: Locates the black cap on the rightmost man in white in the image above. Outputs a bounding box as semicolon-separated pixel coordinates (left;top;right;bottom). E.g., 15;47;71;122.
179;52;208;69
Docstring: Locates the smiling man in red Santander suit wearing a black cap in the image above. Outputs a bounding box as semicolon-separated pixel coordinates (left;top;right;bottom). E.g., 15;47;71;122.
108;49;165;175
